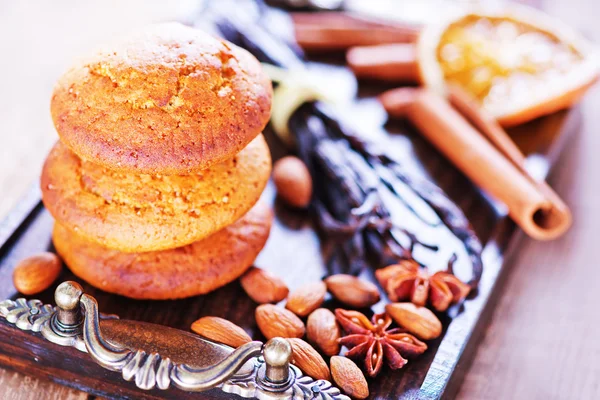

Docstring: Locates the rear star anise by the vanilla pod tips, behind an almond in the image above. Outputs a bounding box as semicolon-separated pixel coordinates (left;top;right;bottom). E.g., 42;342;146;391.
375;260;471;311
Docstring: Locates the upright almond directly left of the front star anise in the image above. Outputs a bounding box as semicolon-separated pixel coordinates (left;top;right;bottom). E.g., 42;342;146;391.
306;308;341;356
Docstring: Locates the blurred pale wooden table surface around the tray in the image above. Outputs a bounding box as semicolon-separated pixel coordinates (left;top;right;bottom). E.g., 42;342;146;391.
0;0;600;400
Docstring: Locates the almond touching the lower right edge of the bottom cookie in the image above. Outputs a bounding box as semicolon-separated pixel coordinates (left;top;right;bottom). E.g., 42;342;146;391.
240;267;290;304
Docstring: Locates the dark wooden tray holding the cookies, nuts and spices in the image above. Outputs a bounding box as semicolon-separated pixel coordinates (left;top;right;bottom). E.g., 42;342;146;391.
0;61;580;399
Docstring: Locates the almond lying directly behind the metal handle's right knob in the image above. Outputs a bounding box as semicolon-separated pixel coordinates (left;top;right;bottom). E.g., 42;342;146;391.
254;304;306;339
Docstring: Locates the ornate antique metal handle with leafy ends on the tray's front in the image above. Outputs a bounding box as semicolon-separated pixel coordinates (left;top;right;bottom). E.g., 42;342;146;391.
0;282;349;400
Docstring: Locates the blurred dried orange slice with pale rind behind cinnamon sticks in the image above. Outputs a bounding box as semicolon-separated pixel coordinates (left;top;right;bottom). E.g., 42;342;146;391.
417;5;599;126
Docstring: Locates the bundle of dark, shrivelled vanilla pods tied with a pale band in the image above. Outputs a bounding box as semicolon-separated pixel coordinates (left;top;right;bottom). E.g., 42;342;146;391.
213;7;482;287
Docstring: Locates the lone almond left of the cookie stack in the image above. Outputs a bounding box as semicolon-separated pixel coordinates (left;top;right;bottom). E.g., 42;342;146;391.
13;252;62;295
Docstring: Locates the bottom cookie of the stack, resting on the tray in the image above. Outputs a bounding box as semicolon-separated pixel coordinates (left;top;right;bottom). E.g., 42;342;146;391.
52;203;273;300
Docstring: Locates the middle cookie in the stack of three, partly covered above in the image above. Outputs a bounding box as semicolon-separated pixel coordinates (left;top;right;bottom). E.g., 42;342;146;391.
41;135;271;252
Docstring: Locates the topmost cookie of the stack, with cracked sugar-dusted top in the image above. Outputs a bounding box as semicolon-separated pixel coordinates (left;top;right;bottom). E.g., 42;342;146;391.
51;23;272;175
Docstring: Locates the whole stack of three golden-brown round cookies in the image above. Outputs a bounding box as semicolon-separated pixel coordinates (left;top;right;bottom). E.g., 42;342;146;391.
41;23;272;299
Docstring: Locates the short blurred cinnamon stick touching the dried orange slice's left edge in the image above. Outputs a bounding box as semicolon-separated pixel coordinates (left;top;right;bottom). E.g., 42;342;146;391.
346;43;419;83
